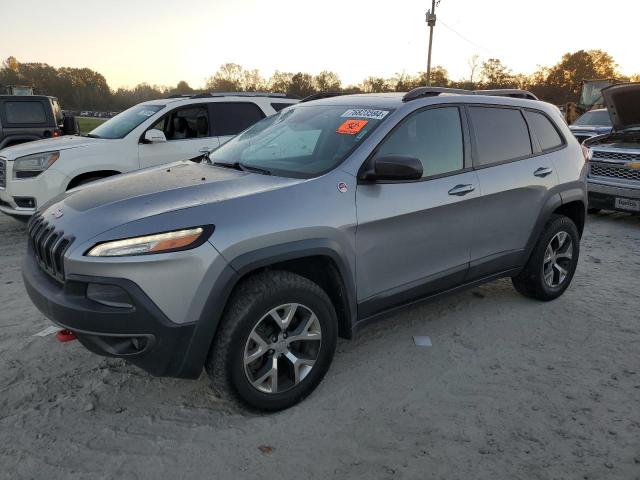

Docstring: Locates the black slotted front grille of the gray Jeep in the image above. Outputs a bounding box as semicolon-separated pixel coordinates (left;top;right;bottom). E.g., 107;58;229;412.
28;214;73;282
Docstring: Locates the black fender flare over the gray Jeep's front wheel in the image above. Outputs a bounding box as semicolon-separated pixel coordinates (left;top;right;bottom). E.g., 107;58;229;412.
177;238;357;378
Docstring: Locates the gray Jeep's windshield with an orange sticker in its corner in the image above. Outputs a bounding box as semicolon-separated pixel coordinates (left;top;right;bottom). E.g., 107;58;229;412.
210;105;391;178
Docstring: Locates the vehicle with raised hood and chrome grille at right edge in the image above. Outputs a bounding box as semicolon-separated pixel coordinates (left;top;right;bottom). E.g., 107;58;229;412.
583;83;640;213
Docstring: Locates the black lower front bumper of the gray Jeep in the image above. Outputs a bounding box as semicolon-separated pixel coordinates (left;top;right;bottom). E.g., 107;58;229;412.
22;249;202;378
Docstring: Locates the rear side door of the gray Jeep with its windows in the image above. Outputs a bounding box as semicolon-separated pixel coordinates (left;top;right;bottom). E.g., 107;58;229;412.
468;105;563;279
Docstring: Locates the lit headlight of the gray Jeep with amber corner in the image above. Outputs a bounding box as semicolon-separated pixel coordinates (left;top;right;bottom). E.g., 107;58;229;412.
87;227;206;257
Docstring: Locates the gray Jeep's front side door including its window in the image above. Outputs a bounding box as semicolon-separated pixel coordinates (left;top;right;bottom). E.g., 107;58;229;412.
356;106;479;317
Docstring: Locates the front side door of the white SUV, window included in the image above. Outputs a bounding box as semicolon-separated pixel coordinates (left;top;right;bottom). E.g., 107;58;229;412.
138;103;219;168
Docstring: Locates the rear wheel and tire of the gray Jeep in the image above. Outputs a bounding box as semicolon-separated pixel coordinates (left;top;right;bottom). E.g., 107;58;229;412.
511;215;580;301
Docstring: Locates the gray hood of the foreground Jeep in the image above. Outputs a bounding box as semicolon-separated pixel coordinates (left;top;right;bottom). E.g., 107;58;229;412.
41;160;304;243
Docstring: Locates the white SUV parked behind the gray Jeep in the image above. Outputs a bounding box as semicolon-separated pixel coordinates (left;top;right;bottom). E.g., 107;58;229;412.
0;92;298;218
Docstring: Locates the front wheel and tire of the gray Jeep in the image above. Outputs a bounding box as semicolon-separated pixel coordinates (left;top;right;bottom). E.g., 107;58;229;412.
205;271;338;411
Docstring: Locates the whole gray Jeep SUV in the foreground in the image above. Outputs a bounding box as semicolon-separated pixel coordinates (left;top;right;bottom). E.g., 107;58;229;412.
23;87;587;410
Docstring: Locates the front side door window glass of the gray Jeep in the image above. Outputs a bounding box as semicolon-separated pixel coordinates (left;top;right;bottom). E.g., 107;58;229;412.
378;107;464;177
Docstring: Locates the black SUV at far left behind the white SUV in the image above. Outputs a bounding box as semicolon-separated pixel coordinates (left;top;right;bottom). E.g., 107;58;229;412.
0;95;77;149
